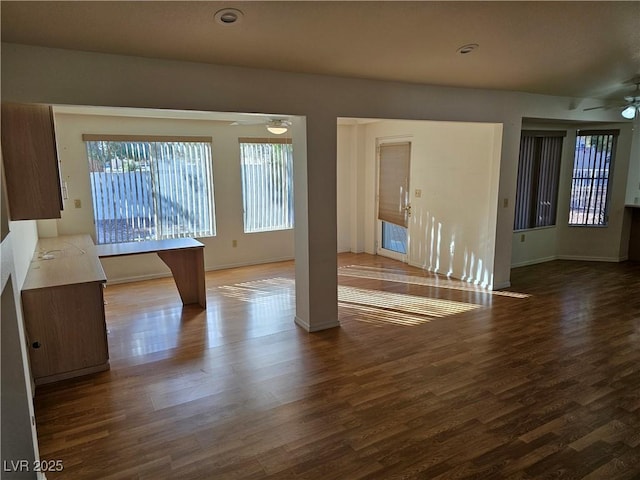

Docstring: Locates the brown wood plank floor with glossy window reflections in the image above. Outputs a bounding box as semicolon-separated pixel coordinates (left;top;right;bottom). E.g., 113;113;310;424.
35;254;640;480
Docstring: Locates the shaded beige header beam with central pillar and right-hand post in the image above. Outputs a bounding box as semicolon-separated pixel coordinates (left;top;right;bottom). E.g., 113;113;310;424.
2;44;632;312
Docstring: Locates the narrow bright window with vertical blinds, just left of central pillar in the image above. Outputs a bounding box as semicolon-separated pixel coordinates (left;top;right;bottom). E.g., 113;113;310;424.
240;138;293;233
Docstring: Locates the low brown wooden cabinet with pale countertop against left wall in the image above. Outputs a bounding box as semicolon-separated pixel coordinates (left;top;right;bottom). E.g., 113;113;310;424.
22;235;109;385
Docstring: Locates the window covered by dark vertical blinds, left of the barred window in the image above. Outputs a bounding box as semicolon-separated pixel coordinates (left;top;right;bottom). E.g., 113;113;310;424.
513;131;565;230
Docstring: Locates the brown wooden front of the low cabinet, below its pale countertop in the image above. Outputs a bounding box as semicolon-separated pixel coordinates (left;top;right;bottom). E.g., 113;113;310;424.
22;282;109;384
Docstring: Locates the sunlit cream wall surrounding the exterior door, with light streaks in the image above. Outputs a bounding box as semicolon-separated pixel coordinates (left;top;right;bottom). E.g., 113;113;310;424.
338;120;502;286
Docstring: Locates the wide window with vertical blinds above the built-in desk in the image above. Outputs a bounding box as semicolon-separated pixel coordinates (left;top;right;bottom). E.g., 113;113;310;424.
83;135;215;244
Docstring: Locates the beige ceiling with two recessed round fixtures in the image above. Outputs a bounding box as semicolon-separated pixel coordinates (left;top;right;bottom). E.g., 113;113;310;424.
1;0;640;100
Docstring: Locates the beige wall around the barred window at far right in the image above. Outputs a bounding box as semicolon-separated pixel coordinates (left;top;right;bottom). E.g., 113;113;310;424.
511;123;633;267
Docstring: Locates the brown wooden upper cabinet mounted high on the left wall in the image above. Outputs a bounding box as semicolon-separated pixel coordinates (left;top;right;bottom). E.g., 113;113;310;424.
1;103;62;220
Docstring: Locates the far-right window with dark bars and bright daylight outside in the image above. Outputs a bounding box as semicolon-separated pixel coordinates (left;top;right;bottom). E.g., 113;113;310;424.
569;130;619;225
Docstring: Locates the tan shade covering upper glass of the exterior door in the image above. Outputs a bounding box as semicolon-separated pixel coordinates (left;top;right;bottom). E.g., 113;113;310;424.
378;142;411;227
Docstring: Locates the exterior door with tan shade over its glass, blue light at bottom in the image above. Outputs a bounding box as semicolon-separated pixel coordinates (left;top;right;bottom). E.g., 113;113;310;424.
376;142;411;262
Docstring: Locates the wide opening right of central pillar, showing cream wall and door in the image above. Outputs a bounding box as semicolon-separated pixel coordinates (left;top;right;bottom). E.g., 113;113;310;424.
337;118;502;288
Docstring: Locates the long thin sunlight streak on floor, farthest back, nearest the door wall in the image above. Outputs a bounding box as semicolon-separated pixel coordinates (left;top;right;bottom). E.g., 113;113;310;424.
338;265;530;298
